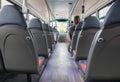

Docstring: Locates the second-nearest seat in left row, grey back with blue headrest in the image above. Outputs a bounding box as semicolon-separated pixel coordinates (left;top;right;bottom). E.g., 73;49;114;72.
28;19;49;58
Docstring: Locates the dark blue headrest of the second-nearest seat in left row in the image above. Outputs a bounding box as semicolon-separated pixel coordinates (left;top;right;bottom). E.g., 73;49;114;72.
28;18;42;30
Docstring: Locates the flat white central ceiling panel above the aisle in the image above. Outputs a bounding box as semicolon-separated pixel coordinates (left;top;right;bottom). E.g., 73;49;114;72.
47;0;77;19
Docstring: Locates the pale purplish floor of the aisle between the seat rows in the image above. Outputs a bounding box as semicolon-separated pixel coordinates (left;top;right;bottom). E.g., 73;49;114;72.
39;43;82;82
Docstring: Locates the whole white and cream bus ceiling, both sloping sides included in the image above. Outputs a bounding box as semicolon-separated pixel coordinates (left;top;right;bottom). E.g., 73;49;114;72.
8;0;113;21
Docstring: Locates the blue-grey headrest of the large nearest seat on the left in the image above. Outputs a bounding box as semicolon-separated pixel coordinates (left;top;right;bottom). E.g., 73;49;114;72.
0;5;27;29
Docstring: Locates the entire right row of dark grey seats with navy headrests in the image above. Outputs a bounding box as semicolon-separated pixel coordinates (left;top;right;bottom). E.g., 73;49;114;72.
72;0;120;82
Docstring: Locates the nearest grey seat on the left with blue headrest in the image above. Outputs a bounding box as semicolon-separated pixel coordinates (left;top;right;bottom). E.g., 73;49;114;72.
0;5;39;73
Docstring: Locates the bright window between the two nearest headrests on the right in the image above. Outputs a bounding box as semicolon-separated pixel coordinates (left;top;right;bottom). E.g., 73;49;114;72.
99;4;112;22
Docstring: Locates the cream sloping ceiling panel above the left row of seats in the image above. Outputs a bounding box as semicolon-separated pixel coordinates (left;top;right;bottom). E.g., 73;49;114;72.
11;0;49;22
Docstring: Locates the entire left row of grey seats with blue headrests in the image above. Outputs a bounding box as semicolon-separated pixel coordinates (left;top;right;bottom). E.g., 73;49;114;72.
0;5;58;81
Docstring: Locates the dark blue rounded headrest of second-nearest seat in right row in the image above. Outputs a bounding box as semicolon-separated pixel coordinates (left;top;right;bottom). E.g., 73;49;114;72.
83;16;100;30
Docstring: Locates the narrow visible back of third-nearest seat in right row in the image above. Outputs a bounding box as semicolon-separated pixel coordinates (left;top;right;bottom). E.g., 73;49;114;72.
71;22;83;50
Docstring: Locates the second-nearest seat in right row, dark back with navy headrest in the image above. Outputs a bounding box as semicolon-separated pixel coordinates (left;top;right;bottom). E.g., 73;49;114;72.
76;16;100;61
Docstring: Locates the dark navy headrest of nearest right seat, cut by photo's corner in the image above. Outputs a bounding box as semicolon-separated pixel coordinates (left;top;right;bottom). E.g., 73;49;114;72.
104;0;120;26
